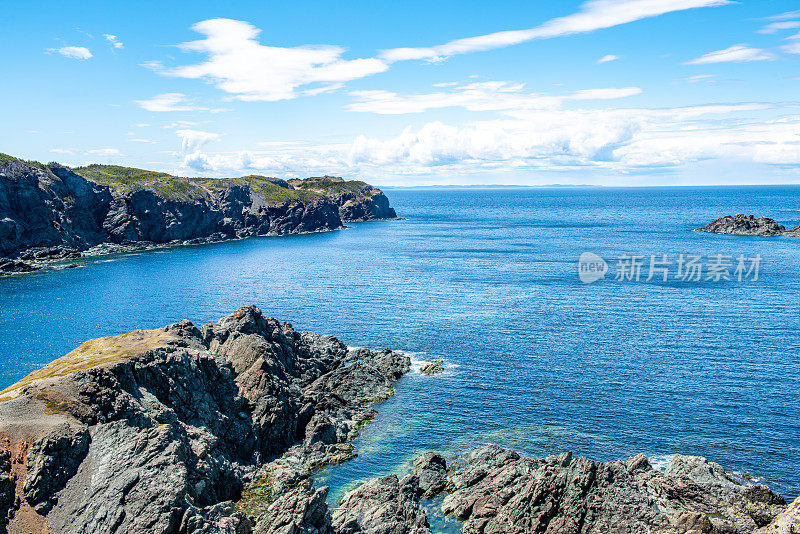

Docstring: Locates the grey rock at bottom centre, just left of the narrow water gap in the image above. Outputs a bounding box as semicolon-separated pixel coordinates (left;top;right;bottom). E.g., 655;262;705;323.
332;475;430;534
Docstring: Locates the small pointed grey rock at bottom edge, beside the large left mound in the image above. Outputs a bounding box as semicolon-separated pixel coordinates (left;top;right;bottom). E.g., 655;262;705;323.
254;481;333;534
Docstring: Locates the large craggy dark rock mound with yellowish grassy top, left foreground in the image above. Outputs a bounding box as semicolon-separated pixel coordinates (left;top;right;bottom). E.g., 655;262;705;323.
0;306;410;533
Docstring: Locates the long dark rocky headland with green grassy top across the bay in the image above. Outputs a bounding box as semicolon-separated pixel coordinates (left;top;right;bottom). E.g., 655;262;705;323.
0;154;397;274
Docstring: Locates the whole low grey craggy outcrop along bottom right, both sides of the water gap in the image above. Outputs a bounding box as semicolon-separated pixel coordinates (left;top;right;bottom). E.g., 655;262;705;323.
322;445;800;534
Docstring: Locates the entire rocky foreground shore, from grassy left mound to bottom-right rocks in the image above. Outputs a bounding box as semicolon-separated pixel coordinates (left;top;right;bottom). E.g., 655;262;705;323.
0;306;800;534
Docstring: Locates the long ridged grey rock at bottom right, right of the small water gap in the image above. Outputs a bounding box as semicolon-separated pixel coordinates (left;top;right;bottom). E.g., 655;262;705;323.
434;445;784;534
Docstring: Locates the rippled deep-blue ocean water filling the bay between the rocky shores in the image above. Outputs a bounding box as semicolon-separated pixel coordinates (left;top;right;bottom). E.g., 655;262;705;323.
0;187;800;510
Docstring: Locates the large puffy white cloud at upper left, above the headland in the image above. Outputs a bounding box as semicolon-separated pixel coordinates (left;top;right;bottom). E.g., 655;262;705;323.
159;18;388;101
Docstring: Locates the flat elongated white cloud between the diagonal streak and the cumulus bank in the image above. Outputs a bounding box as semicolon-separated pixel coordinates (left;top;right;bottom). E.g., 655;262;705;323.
345;81;642;115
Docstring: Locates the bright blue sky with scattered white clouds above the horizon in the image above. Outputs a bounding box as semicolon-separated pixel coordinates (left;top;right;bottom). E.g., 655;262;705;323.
0;0;800;185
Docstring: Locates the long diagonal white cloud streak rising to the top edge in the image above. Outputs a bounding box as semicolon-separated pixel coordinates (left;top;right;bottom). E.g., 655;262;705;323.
380;0;731;62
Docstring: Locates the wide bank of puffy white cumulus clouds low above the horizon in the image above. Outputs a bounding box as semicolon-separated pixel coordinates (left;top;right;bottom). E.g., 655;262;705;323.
172;103;800;179
